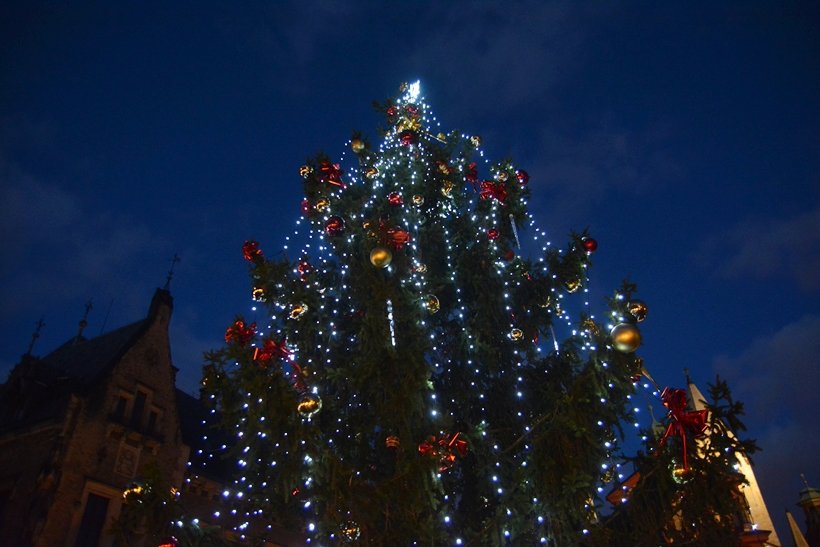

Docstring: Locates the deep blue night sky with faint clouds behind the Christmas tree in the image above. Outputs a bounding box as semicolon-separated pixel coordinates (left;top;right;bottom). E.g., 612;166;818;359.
0;1;820;543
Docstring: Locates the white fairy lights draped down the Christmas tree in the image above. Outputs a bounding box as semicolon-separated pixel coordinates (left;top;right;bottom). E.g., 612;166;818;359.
189;82;668;545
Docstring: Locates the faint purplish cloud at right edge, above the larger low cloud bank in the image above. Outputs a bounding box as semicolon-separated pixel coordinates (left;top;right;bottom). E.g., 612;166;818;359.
698;207;820;292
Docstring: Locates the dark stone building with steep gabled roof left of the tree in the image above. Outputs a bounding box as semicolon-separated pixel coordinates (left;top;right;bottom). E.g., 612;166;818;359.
0;290;190;547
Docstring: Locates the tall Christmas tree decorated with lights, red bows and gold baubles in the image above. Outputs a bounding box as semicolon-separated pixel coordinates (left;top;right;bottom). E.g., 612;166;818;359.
203;84;756;545
